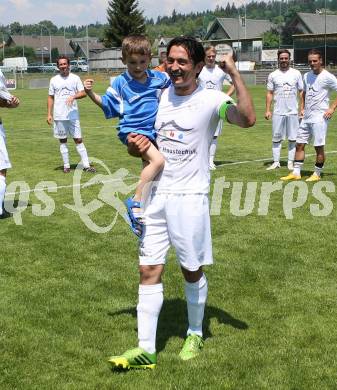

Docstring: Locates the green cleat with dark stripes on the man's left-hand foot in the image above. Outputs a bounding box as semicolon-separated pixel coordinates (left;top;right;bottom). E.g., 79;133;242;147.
109;348;157;370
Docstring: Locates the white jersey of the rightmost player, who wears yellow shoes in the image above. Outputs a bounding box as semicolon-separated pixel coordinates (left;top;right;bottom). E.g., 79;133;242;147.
303;69;337;123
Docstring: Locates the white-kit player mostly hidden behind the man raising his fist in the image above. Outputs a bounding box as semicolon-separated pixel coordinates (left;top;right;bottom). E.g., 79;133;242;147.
198;46;235;170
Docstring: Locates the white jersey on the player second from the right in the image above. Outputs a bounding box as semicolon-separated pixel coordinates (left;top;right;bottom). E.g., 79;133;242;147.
267;68;303;115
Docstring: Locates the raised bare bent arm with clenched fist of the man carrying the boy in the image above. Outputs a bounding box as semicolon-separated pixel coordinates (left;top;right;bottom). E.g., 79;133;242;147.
219;54;256;127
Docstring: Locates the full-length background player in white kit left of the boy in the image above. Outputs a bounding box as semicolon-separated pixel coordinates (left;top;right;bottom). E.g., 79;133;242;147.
47;56;96;173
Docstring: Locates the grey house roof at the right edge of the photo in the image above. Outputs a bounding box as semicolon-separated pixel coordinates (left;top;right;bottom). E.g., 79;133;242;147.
291;12;337;34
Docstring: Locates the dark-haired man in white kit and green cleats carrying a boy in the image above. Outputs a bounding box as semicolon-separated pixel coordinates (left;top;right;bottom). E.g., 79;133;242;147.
109;37;255;369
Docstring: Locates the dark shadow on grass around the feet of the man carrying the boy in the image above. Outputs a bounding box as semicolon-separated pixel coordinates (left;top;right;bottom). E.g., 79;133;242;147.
108;299;248;352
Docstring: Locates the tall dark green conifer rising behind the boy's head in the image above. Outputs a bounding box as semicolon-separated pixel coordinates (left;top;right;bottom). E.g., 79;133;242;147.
104;0;145;47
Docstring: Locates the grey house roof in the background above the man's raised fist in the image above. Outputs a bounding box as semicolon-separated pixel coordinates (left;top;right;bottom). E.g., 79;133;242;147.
204;18;274;40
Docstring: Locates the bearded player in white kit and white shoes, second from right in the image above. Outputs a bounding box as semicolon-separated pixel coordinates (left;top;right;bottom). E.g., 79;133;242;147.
264;49;303;170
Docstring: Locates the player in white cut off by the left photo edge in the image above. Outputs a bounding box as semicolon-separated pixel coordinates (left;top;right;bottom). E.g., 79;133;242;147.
0;70;19;219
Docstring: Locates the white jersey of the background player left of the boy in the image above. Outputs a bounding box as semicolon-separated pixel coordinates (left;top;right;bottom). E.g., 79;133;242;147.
48;73;84;120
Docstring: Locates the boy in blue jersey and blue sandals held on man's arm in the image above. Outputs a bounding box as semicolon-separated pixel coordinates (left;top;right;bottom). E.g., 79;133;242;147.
84;35;170;237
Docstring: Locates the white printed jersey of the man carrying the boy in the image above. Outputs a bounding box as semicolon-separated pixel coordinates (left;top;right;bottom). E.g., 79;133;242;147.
155;86;231;194
